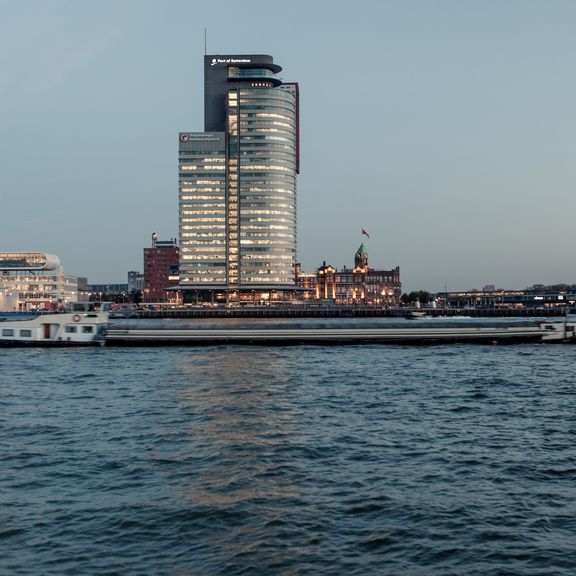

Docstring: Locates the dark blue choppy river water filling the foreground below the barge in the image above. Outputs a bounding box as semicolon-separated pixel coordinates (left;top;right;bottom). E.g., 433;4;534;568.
0;344;576;576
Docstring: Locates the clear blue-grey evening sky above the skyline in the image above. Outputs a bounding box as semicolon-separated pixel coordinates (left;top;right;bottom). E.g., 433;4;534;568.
0;0;576;291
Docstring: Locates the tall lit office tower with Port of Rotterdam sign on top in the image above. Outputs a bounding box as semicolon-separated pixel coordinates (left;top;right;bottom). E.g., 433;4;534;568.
179;55;299;302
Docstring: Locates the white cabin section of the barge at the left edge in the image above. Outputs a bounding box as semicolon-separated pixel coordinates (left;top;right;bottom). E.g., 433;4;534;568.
0;302;110;347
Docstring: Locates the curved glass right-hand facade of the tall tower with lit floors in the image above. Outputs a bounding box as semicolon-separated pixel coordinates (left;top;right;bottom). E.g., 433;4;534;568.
229;86;296;285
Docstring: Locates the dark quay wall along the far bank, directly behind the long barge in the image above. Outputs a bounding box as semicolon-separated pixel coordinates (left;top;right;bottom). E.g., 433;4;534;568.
130;306;565;318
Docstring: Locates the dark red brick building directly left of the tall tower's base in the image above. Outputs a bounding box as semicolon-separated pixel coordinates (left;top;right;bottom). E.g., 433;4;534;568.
142;233;179;303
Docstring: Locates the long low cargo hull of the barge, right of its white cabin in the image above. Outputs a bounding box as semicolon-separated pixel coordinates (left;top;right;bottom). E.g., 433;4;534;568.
106;326;562;346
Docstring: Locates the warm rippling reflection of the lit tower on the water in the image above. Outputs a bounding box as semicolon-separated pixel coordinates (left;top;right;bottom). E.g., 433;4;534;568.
175;347;306;562
